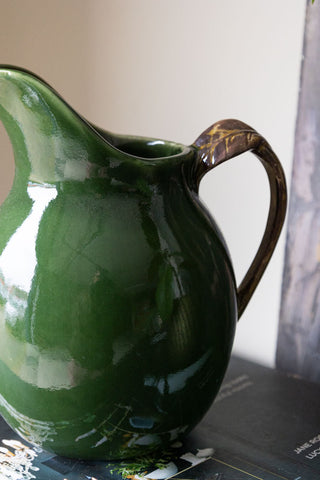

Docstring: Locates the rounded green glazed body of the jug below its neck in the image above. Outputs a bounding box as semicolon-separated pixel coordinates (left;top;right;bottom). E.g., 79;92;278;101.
0;158;236;458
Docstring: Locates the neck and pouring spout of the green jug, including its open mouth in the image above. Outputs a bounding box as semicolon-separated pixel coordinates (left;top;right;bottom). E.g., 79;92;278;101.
0;65;194;188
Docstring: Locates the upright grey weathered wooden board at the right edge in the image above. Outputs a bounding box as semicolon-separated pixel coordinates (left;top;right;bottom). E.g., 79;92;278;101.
276;1;320;382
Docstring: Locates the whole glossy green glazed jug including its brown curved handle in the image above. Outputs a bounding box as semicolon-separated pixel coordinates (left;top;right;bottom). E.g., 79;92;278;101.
0;66;286;460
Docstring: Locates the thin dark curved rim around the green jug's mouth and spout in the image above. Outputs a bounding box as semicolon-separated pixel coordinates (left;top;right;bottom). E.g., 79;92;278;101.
0;64;195;164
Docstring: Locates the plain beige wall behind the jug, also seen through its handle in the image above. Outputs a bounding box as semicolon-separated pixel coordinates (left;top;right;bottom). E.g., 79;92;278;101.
0;0;305;365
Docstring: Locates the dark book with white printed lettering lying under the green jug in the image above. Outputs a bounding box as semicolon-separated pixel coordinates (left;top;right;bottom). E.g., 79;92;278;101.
0;357;320;480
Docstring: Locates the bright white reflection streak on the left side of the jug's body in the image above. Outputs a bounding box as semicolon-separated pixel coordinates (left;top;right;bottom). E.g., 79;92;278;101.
0;184;57;292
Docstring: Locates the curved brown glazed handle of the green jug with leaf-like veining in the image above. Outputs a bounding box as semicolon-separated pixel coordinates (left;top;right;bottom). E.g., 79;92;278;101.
193;120;287;318
